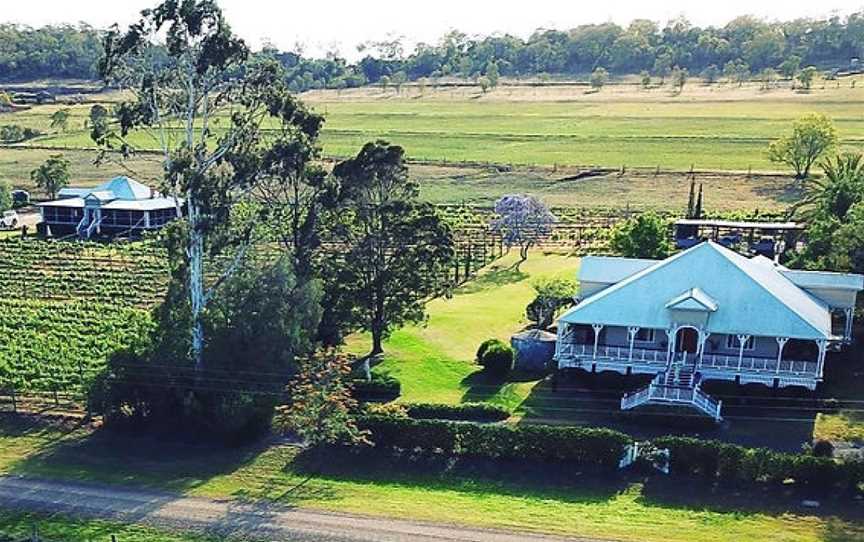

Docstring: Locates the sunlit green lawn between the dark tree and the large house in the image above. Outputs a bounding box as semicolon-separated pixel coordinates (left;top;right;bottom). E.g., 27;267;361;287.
348;251;579;408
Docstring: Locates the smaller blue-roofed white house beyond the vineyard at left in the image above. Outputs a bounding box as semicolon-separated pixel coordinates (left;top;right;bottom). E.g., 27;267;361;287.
39;176;183;239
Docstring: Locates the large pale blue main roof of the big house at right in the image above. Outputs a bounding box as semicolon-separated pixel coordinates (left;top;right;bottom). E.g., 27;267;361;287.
560;241;832;339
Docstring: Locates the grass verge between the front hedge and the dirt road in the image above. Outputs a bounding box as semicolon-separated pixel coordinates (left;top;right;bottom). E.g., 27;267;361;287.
0;420;864;542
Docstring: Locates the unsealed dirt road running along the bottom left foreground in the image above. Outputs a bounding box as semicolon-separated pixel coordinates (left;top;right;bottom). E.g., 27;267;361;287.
0;476;599;542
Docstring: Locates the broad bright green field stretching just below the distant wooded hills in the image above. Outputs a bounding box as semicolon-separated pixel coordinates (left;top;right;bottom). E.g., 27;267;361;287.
10;79;864;171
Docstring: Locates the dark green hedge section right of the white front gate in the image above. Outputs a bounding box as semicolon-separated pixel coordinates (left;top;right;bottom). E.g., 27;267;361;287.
652;437;864;496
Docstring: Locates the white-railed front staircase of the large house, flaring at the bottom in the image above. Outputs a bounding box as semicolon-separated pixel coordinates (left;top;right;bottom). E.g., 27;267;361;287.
621;358;723;422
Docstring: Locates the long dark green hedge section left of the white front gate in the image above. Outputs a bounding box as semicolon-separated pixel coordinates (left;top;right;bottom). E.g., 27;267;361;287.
361;415;631;468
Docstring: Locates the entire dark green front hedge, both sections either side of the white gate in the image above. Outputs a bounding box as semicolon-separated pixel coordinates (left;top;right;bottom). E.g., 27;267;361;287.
360;416;864;492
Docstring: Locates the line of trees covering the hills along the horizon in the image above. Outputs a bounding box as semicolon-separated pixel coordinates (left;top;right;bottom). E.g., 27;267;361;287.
0;12;864;92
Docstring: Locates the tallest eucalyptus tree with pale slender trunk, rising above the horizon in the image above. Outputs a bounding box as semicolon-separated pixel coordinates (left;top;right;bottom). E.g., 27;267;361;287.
92;0;320;370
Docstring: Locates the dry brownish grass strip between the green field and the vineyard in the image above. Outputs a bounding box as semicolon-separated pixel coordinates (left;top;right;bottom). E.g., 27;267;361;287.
0;147;801;212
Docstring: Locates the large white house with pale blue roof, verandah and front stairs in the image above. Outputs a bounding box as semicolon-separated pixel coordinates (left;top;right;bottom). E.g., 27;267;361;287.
555;241;864;420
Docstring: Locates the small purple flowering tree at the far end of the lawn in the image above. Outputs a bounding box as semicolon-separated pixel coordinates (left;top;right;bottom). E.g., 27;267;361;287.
492;194;558;270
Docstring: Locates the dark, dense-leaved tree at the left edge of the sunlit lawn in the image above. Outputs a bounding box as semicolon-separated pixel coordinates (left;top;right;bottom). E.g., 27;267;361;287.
331;141;454;366
